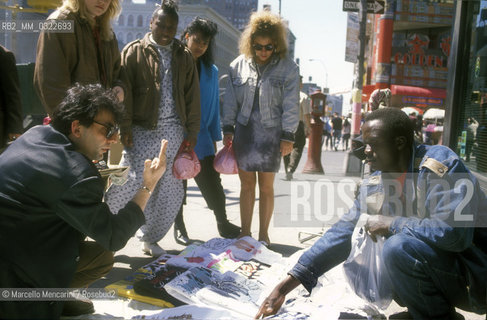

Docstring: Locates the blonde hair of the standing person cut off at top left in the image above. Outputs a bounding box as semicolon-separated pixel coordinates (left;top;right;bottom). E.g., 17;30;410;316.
59;0;122;41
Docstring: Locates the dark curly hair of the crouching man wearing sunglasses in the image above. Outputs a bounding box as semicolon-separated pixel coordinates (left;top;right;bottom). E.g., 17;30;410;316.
51;83;123;136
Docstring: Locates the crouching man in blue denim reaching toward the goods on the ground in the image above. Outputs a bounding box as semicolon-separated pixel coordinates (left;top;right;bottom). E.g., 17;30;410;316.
256;108;487;319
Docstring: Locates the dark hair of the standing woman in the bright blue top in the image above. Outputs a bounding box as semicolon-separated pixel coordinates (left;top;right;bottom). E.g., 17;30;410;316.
181;17;218;67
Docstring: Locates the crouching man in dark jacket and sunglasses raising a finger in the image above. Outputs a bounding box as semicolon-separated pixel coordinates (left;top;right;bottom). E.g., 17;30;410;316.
0;85;167;319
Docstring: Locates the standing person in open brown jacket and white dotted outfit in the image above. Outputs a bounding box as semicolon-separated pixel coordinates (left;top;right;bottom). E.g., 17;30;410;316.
105;0;200;256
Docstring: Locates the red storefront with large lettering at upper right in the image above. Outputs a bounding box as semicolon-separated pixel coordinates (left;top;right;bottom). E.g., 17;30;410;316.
363;0;454;110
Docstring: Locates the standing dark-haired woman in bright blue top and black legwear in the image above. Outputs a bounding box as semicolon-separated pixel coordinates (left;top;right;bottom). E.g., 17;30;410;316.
174;17;240;245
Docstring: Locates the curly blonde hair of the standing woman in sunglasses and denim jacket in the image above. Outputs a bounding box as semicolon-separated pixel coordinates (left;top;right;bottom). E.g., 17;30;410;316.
239;11;287;59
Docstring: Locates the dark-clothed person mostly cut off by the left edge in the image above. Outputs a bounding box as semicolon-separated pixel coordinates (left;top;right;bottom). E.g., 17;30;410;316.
0;46;24;153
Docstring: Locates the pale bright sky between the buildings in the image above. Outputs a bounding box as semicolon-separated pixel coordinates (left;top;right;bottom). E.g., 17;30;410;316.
258;0;353;93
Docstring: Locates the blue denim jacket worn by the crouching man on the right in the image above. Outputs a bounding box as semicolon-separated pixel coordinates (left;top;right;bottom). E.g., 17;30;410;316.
289;145;487;312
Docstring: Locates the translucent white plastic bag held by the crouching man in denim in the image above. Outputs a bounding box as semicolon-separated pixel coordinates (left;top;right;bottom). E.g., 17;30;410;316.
343;219;392;310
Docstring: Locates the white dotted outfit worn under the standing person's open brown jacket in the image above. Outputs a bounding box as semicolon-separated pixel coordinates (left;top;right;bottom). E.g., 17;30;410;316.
105;44;184;243
